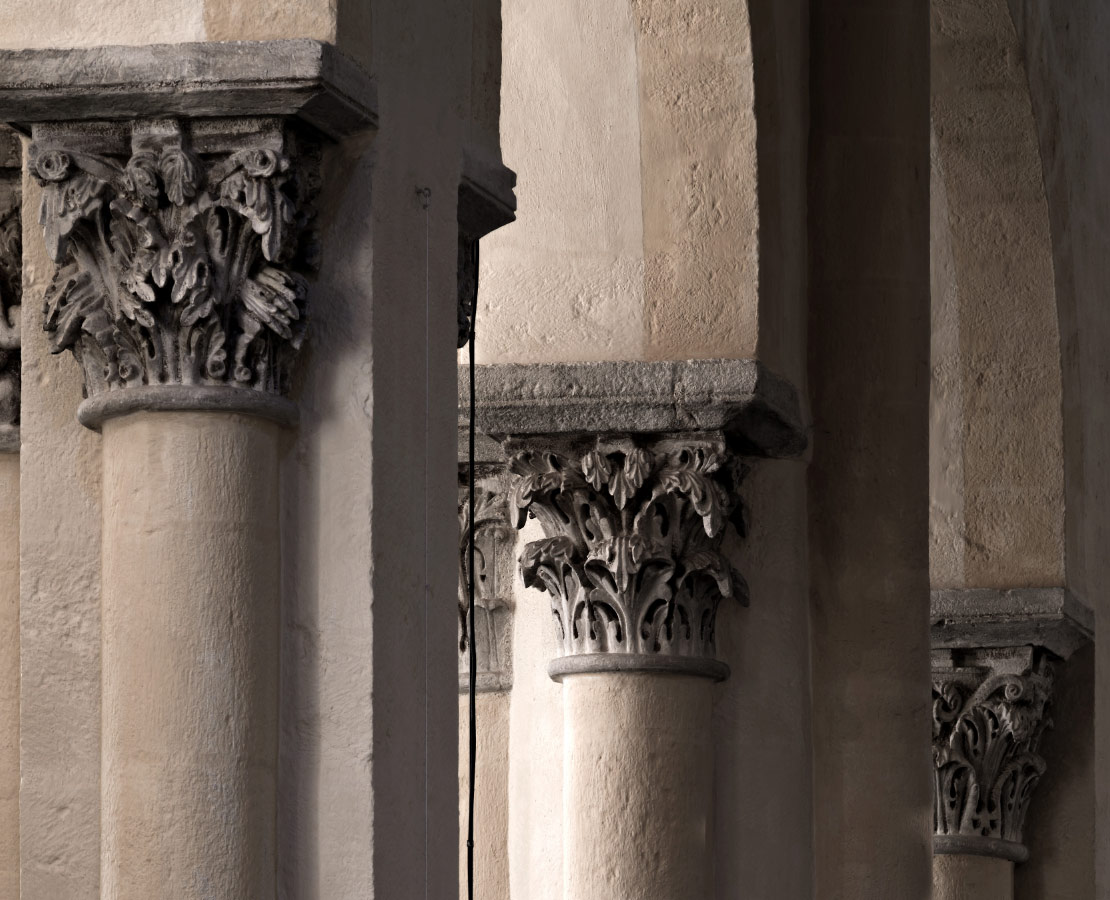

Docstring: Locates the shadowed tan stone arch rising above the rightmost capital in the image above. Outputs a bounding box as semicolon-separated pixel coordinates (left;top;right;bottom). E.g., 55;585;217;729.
929;0;1064;588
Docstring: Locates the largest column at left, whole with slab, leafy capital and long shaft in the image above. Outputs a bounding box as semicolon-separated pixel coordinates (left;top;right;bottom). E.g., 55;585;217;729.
4;41;372;900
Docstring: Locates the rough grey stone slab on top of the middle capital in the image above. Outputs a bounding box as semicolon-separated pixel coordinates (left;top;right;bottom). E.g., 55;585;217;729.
458;360;808;458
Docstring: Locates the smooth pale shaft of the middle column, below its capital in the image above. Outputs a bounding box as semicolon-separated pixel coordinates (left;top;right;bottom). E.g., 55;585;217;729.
563;671;713;900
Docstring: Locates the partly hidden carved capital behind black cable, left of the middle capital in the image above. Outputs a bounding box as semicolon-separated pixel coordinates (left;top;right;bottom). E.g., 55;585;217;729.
458;465;516;692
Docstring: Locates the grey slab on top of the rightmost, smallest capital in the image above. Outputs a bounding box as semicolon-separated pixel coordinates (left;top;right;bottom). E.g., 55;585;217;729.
929;587;1094;659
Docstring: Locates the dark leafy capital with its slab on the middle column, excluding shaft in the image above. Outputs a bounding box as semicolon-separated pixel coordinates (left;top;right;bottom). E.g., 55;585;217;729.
458;360;807;679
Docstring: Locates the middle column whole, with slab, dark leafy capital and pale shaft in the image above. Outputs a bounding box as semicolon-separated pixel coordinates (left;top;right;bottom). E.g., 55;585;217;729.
463;361;804;900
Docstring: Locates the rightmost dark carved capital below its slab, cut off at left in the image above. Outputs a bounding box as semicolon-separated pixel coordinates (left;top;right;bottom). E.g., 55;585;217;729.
932;647;1052;862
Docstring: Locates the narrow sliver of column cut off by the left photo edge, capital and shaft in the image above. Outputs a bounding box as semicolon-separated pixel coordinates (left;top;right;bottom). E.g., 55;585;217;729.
0;130;22;897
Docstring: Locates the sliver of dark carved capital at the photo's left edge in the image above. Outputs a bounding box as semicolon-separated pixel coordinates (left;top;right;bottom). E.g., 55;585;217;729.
0;129;23;452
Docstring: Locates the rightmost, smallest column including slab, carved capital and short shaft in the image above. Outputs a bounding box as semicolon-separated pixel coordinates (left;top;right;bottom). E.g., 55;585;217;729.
930;587;1094;900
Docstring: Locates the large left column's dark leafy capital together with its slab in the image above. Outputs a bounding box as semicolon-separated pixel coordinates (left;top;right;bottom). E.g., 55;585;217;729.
0;40;376;427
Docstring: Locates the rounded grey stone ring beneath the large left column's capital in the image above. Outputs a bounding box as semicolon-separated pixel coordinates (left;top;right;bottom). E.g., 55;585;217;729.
77;384;297;432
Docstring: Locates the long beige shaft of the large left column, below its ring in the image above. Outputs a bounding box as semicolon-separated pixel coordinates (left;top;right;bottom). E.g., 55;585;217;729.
101;412;281;900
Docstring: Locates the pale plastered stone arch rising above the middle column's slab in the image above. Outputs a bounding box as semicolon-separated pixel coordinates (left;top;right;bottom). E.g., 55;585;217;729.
477;0;760;362
